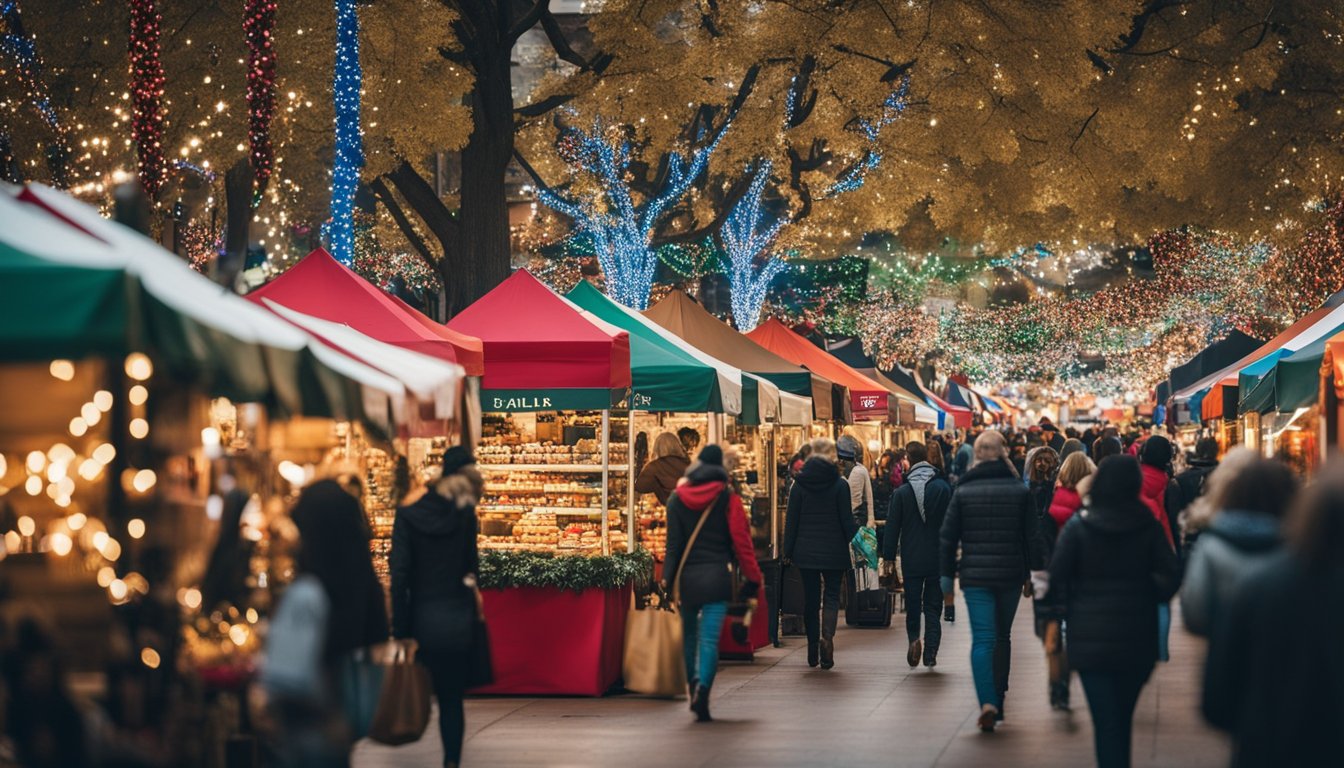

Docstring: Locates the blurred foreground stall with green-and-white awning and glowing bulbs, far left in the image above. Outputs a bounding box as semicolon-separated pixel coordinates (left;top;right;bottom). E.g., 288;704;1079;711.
0;188;464;763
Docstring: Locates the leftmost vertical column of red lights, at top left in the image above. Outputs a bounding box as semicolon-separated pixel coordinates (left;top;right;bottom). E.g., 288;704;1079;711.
130;0;165;199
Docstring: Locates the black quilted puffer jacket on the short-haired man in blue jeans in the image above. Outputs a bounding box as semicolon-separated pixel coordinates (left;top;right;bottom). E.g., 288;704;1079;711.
942;460;1044;589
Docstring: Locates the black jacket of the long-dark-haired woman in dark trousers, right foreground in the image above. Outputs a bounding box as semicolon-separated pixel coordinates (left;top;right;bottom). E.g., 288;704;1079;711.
1050;500;1180;671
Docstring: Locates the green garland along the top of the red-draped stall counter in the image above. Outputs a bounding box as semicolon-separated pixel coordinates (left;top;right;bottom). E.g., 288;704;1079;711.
478;550;653;590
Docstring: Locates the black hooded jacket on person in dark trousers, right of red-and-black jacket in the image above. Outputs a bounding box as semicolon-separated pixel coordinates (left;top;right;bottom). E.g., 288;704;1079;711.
784;457;859;570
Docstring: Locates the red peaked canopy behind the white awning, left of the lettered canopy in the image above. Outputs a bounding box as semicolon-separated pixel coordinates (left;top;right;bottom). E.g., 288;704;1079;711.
247;247;485;377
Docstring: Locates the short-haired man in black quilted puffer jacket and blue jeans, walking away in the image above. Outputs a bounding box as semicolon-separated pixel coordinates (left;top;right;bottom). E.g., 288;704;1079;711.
939;432;1040;733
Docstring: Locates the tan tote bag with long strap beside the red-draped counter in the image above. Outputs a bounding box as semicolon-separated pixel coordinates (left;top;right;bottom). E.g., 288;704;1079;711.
622;506;714;697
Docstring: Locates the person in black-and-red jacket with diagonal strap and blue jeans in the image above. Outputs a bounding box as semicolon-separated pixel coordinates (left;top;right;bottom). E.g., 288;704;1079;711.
663;444;765;722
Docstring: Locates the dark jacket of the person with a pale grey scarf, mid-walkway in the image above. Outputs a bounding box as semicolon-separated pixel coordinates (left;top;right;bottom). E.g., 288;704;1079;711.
882;461;952;578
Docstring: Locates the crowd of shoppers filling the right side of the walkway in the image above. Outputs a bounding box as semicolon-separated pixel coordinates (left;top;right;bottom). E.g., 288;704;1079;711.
784;421;1344;768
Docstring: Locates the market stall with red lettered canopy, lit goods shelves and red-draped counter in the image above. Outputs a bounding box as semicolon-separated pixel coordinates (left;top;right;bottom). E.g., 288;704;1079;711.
449;270;634;695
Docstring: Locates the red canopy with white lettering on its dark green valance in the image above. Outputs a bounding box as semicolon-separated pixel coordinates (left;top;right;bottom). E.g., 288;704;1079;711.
448;269;630;410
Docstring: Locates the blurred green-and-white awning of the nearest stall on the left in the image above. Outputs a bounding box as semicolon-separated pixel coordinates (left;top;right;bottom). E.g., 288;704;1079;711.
0;187;461;432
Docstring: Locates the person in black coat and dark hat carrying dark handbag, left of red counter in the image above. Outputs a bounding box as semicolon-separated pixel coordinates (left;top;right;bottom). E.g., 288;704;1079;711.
388;445;484;767
